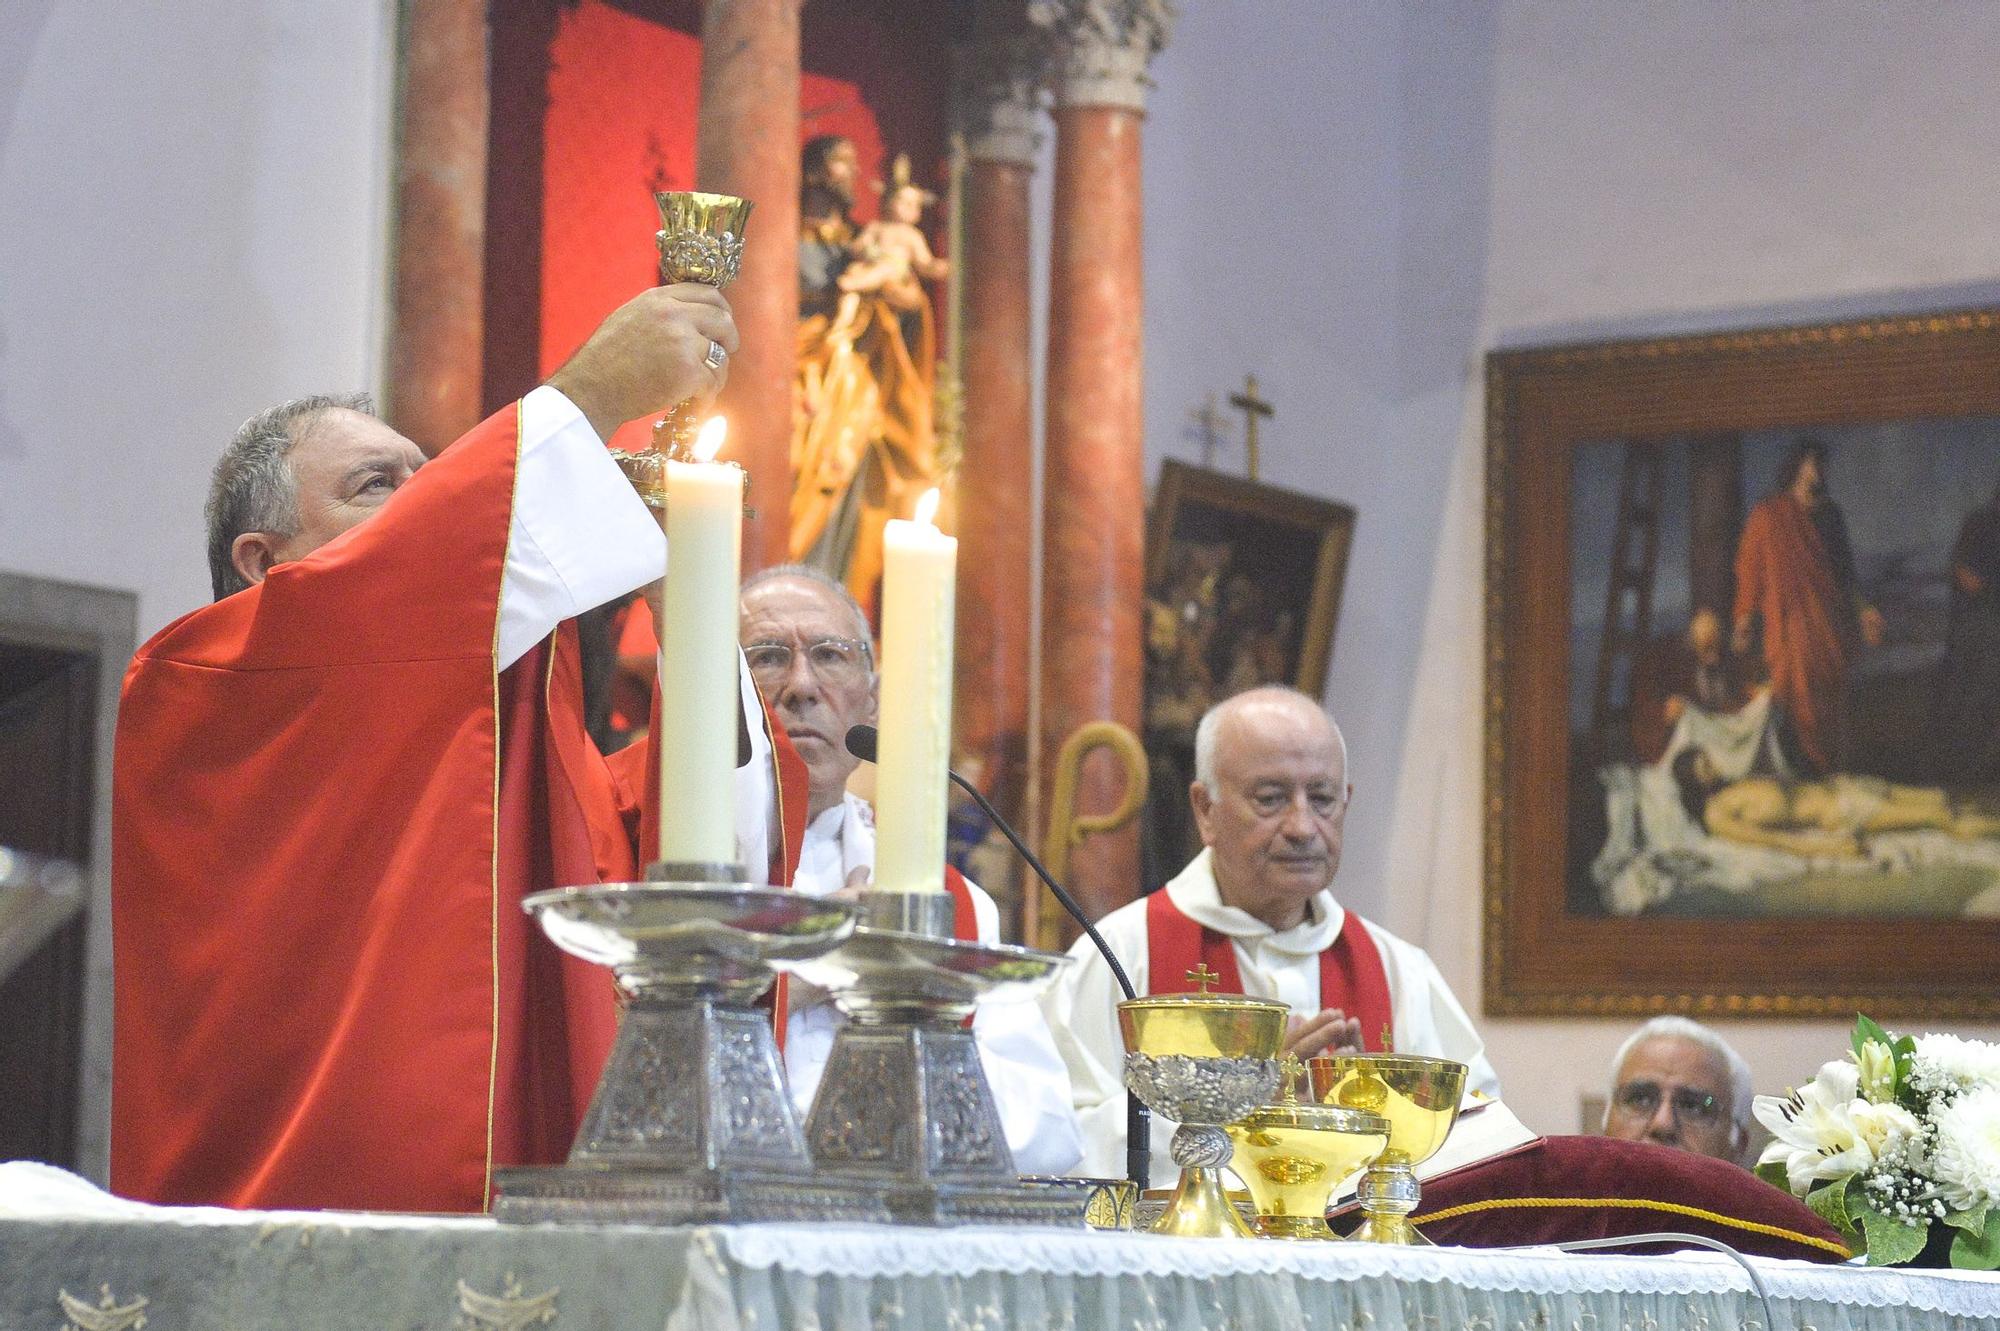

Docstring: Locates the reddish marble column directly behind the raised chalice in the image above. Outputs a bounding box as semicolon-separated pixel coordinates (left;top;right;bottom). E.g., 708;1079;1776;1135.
694;0;802;574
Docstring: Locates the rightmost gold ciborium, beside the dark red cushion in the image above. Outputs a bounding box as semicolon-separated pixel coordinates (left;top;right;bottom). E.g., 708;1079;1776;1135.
1310;1053;1466;1245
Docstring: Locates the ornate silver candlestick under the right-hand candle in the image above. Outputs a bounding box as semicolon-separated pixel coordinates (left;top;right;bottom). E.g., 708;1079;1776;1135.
798;891;1090;1227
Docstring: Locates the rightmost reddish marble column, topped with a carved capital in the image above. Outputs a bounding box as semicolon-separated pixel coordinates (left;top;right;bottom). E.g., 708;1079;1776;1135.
1030;0;1172;915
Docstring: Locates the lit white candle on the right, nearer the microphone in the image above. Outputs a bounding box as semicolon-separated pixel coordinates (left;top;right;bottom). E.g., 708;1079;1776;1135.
874;490;958;891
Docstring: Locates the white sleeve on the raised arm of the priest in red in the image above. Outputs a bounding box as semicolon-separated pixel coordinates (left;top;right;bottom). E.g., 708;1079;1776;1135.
498;384;666;669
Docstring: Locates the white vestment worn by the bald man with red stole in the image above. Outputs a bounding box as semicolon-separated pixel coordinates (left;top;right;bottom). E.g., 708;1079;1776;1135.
1042;849;1500;1187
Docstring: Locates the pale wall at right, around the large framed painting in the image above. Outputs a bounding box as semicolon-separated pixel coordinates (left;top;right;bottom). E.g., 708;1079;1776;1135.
1146;0;2000;1131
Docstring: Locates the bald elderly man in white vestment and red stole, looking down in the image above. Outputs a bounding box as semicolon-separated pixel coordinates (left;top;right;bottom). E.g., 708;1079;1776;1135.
1044;687;1500;1179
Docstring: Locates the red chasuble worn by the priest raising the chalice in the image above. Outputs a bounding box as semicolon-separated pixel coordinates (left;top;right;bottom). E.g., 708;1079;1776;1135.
112;408;804;1211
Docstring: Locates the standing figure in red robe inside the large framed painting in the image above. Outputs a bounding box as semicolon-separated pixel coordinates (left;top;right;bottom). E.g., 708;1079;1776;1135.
1734;440;1882;773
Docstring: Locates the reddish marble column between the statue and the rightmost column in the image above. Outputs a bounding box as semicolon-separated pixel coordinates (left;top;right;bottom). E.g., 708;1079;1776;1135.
952;36;1044;843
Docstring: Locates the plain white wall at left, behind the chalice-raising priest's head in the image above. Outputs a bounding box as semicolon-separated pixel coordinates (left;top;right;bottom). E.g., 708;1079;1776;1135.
0;0;394;638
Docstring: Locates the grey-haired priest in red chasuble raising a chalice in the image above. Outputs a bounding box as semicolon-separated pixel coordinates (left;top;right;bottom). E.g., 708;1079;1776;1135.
112;286;792;1211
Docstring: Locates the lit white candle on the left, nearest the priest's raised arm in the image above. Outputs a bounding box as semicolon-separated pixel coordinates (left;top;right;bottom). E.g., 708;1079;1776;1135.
652;416;748;873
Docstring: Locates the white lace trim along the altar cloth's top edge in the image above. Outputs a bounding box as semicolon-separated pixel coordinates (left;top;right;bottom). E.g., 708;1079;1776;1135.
714;1225;2000;1317
